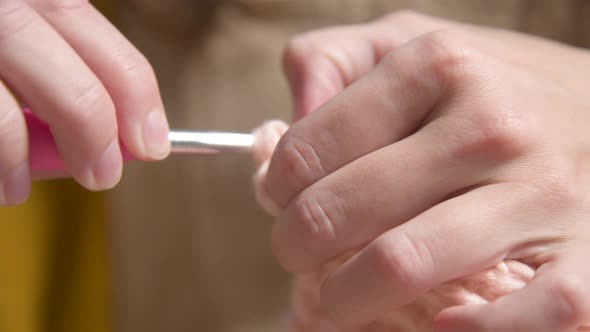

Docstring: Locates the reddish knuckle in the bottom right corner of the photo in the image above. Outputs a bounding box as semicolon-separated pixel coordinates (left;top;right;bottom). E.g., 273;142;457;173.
549;274;590;328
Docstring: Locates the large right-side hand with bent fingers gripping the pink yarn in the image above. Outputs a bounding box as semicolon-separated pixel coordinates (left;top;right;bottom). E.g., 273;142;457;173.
264;13;590;332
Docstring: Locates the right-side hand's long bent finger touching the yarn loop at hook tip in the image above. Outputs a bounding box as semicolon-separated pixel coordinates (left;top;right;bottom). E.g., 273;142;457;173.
265;29;490;207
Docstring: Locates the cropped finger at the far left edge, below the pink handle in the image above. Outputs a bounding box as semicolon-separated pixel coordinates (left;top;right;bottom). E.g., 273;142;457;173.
0;82;31;206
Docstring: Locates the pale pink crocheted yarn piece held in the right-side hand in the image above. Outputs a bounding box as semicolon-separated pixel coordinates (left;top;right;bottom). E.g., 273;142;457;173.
253;121;534;332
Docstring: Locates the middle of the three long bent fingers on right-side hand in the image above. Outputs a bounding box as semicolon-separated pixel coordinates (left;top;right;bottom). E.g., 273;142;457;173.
272;119;495;272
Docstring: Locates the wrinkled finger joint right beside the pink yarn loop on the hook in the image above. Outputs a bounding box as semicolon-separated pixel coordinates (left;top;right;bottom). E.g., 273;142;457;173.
275;133;325;190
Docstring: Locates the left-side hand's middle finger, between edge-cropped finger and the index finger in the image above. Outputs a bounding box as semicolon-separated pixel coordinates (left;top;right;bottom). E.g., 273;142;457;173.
0;1;122;190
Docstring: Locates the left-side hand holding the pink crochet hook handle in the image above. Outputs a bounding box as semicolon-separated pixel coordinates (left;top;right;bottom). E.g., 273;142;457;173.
0;0;170;205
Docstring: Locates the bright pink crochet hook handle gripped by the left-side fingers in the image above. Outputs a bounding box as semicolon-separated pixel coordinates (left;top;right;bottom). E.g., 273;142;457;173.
23;109;134;172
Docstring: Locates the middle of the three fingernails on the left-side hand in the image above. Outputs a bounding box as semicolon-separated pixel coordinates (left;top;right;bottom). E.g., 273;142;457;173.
89;138;123;190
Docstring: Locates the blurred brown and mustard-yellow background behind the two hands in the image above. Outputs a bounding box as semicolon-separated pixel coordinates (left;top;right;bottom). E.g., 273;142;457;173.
0;0;590;332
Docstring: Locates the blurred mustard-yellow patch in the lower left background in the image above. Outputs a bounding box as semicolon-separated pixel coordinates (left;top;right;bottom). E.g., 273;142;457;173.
0;0;113;332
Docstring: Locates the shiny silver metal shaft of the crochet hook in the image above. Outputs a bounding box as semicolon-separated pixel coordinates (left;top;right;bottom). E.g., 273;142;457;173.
168;130;254;154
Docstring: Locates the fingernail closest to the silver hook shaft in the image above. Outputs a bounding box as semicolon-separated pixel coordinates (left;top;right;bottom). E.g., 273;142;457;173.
143;109;170;160
